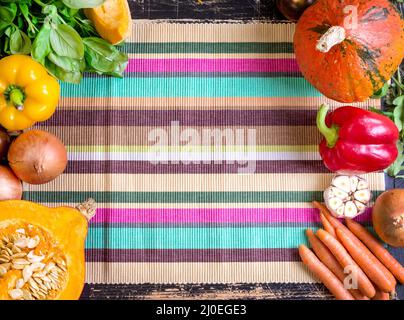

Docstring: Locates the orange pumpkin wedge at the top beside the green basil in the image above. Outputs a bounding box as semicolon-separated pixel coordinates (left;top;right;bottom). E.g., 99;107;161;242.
84;0;132;44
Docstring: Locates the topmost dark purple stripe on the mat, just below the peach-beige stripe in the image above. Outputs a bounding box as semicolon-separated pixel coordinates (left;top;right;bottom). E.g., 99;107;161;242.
39;110;316;127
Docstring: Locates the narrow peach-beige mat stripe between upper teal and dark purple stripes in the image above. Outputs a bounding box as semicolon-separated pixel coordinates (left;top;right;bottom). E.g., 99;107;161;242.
59;97;380;110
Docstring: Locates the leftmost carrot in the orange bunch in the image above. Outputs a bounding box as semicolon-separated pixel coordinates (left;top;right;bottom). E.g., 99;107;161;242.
299;245;354;300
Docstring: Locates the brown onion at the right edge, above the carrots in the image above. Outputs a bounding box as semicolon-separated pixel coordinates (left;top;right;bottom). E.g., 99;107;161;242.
372;189;404;247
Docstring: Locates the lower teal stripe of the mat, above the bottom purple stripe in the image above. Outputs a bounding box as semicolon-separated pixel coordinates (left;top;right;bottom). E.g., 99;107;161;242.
86;227;307;249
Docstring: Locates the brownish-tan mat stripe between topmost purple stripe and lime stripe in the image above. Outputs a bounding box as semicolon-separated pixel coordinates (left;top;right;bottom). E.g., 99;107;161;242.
41;126;320;146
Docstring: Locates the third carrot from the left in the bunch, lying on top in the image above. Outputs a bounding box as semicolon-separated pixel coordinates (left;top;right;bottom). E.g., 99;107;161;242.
316;229;376;298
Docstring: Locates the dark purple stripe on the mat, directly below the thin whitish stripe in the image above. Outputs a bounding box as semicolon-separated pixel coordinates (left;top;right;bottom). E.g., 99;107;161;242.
65;160;329;174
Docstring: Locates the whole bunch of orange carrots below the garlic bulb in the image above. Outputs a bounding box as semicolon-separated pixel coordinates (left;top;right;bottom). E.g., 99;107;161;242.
299;201;404;300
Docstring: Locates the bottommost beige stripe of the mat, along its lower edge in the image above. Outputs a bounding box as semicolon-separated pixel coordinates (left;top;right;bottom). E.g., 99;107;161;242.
86;262;317;284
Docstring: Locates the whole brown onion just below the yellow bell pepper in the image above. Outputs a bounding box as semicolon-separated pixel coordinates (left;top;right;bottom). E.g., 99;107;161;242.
8;130;67;184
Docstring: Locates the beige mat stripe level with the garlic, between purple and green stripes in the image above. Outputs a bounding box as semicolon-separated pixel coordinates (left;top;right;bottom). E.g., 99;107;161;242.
26;173;384;192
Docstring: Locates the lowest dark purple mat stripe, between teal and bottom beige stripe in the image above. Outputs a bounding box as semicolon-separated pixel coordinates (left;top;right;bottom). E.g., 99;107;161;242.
86;249;299;262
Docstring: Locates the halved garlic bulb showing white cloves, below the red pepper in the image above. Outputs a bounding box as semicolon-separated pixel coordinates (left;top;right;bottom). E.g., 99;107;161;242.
324;175;372;218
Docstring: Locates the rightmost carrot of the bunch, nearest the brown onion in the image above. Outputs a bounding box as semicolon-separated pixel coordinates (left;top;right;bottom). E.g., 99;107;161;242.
346;219;404;284
